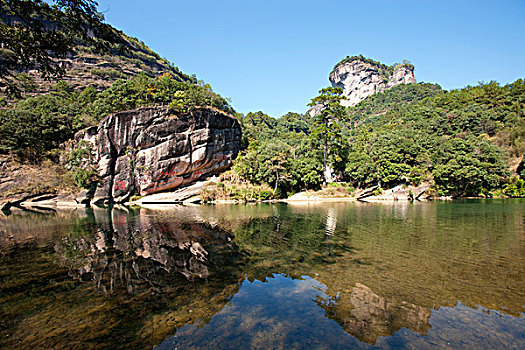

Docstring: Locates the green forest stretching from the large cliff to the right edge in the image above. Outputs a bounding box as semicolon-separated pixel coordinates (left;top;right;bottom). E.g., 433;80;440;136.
236;79;525;196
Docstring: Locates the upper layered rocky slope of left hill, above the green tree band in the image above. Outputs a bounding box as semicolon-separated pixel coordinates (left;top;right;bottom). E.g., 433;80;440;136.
0;1;192;98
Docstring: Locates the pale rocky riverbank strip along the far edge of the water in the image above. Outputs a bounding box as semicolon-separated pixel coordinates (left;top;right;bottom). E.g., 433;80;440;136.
0;162;520;214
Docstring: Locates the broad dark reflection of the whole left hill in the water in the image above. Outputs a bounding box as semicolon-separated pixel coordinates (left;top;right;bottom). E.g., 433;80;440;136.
0;210;244;349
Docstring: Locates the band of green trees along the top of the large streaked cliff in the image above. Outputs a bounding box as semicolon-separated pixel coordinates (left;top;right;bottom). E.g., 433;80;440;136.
0;74;233;160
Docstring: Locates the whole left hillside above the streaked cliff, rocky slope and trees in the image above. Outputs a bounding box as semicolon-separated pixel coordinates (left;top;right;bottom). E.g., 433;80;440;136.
0;0;234;162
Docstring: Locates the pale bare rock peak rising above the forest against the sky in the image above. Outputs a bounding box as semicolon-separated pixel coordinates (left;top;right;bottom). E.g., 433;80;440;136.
329;60;416;107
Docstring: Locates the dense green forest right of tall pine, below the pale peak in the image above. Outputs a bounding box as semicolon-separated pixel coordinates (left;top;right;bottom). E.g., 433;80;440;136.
346;80;525;196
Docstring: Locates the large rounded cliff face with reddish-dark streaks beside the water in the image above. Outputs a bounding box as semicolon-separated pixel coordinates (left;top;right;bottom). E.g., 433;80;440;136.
66;107;241;203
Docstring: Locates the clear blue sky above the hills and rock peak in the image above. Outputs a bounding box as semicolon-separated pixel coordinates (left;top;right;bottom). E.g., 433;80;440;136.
98;0;525;117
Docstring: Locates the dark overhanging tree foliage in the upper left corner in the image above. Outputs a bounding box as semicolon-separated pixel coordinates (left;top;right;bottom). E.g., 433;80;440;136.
0;0;124;94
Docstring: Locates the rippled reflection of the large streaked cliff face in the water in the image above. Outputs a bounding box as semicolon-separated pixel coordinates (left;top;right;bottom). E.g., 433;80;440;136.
55;210;240;293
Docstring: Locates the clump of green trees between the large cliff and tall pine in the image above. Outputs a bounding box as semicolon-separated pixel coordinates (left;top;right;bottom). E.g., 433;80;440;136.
235;112;322;197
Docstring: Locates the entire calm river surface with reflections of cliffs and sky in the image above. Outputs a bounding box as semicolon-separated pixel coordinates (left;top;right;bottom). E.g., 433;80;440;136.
0;200;525;349
